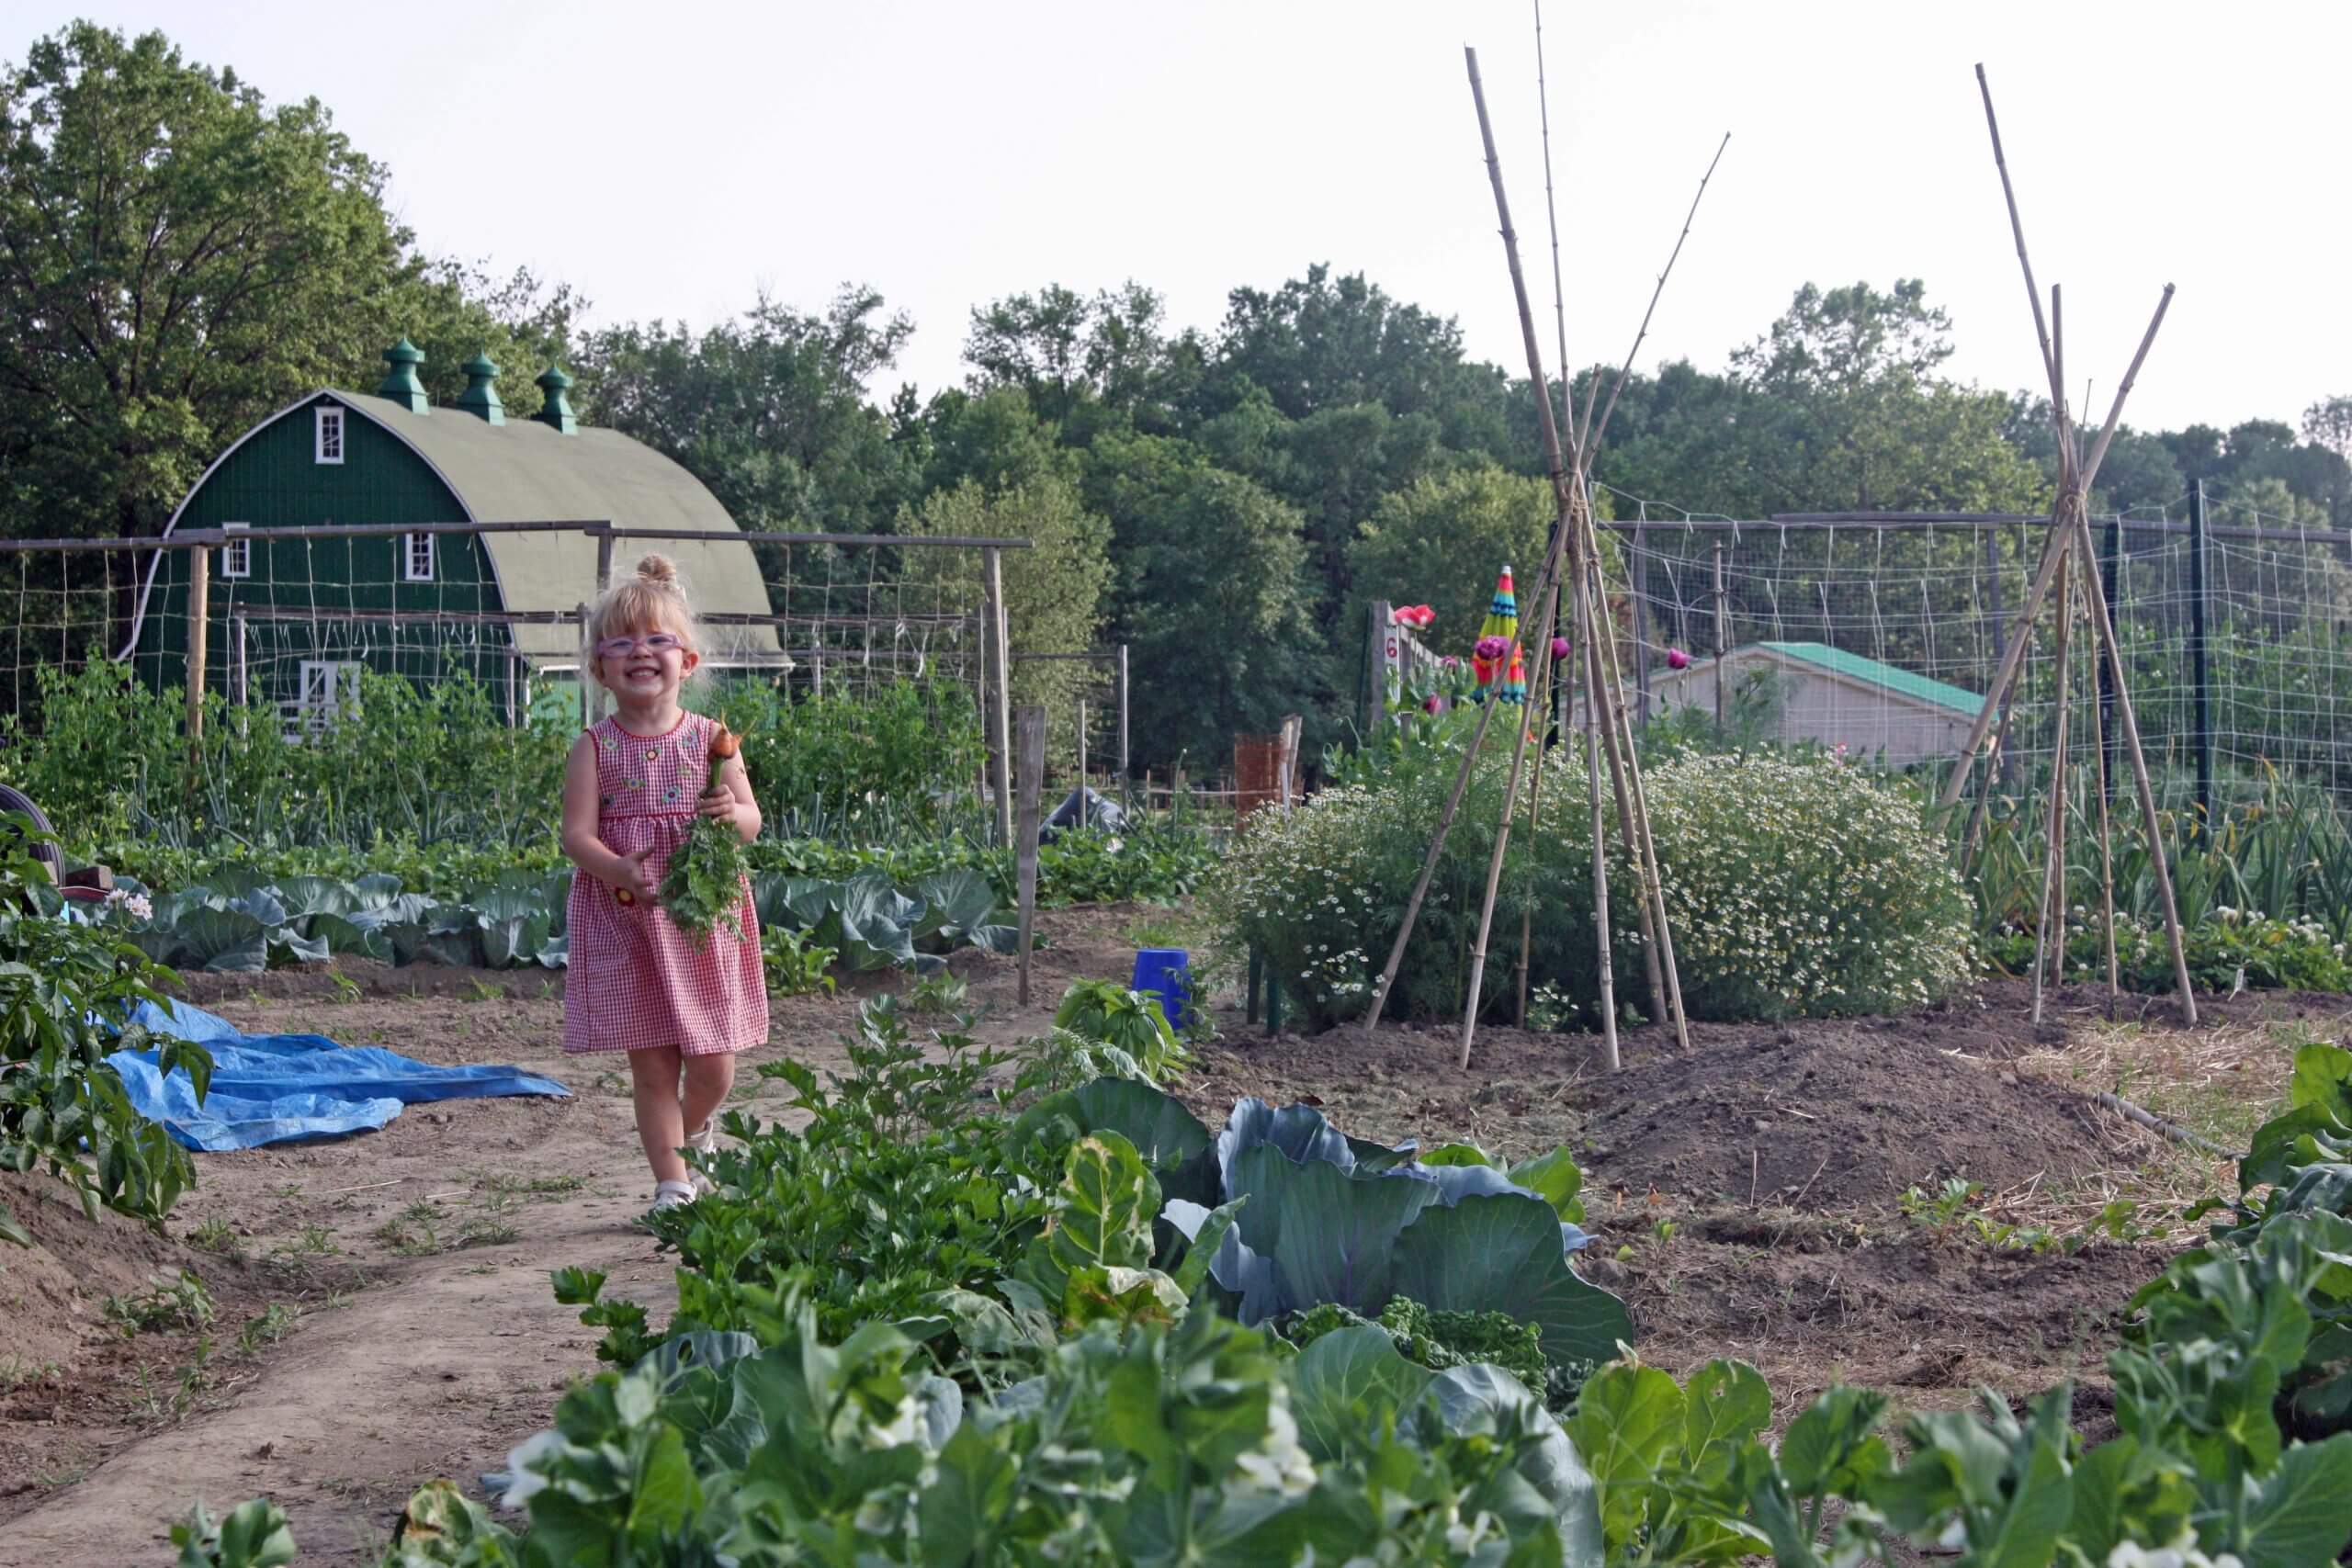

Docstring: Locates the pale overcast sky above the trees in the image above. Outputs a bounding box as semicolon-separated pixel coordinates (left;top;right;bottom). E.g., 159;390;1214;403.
0;0;2352;453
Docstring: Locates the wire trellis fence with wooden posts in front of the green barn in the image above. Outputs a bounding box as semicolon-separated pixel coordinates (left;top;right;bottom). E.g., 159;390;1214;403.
0;522;1028;761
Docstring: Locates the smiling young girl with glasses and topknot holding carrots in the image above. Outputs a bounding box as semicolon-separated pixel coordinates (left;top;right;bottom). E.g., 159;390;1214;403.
564;555;767;1208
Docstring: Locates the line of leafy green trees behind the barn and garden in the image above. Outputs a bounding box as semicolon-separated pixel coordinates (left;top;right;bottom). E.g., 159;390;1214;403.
0;24;2352;766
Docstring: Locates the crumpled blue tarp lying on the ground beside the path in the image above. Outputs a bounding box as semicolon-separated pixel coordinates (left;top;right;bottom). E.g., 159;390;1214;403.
106;1001;571;1152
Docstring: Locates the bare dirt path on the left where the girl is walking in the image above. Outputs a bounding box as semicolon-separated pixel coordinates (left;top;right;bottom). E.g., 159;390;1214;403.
0;909;1157;1568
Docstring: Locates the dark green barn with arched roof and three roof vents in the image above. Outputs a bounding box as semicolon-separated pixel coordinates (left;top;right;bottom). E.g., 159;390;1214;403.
122;339;783;727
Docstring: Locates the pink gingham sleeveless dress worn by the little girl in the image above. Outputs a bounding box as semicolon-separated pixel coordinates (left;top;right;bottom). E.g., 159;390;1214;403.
564;712;767;1055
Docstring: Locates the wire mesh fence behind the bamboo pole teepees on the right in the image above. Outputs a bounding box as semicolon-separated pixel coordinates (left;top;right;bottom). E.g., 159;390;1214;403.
1613;493;2352;808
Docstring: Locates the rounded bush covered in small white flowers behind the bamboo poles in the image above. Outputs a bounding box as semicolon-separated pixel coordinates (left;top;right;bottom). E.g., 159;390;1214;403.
1206;743;1975;1027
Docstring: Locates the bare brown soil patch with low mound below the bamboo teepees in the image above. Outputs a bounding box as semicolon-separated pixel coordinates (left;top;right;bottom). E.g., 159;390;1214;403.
1181;983;2352;1420
